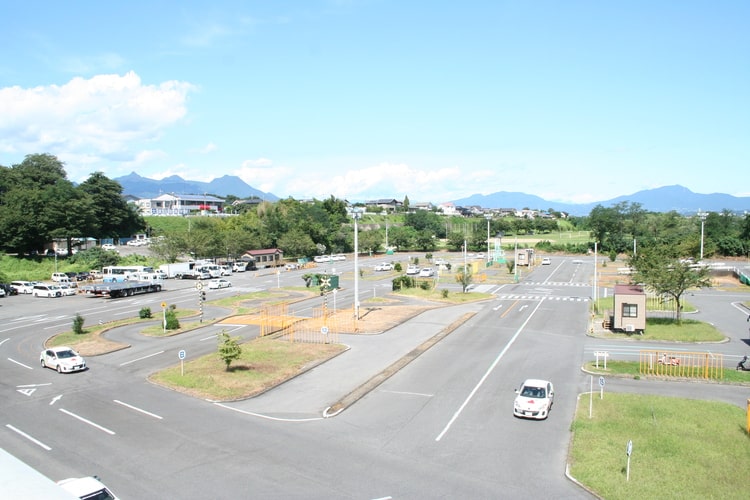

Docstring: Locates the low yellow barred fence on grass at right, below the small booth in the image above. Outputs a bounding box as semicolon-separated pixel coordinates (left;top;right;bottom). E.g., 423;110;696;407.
638;350;724;379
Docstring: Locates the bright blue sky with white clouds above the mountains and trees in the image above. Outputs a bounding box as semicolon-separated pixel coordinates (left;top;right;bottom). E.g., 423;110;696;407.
0;0;750;203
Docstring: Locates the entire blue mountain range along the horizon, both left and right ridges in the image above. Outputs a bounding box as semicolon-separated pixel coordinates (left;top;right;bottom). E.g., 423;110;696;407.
114;172;750;216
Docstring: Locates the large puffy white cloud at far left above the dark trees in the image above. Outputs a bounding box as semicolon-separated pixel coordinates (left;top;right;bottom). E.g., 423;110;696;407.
0;71;195;183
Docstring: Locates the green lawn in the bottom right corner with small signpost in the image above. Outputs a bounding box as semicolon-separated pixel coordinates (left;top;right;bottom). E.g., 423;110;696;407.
570;393;750;500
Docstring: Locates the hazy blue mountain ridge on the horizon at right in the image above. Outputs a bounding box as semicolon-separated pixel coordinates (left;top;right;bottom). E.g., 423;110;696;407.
452;185;750;216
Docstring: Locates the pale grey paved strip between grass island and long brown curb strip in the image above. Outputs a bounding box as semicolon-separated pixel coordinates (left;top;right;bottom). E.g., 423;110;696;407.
223;302;484;420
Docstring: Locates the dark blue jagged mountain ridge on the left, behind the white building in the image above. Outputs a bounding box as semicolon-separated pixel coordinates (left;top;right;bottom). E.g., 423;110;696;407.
113;172;279;201
